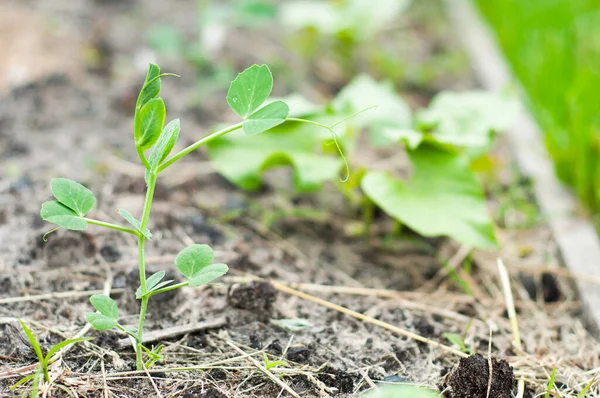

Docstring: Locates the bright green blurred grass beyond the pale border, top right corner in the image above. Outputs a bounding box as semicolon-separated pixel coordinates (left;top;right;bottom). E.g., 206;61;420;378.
473;0;600;214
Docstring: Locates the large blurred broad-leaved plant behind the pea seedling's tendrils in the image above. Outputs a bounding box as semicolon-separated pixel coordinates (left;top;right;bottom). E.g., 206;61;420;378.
208;75;518;248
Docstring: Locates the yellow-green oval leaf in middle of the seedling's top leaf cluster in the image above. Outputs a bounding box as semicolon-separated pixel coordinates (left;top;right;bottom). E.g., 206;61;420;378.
133;98;167;150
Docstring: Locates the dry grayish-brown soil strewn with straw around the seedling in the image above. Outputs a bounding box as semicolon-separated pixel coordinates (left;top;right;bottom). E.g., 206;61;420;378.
0;0;600;398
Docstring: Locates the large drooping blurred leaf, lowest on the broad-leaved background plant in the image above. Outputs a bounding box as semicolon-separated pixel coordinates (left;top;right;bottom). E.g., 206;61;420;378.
361;146;497;249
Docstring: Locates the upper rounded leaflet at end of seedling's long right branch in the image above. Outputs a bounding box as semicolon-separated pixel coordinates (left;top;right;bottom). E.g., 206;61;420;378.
227;65;273;119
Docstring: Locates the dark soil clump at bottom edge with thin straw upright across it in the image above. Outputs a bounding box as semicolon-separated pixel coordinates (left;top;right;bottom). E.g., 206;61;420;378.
444;354;516;398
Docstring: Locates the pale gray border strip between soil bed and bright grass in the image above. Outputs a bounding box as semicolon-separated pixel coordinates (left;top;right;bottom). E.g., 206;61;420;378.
447;0;600;336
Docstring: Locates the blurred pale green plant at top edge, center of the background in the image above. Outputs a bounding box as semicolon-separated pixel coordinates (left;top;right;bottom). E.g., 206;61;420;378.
279;0;411;81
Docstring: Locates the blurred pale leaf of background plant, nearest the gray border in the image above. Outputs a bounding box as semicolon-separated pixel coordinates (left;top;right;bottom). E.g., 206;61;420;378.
417;91;520;148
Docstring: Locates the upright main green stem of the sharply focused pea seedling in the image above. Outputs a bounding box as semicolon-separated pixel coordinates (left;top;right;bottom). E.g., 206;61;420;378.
135;173;156;370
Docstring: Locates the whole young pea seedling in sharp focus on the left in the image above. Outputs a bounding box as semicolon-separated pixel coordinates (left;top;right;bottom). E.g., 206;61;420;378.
41;64;340;370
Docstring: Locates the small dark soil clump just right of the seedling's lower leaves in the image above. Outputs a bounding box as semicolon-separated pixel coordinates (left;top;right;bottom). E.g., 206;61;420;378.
227;282;277;319
